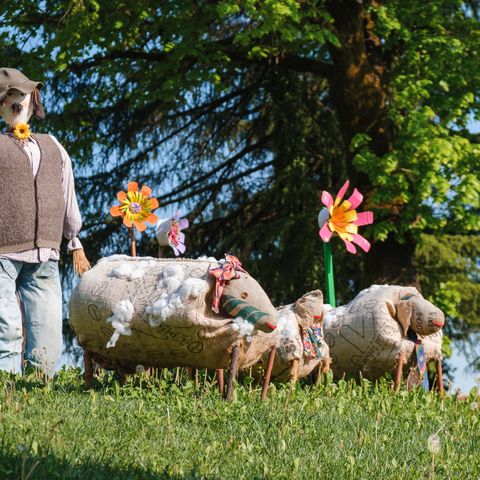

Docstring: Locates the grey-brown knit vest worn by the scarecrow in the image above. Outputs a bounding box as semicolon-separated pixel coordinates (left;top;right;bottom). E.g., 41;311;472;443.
0;134;65;253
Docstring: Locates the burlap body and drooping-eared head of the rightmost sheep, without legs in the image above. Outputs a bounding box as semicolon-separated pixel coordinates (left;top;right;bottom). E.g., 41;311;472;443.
324;285;444;380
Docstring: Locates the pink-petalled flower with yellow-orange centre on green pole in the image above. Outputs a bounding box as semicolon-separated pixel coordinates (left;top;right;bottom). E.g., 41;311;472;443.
318;180;373;253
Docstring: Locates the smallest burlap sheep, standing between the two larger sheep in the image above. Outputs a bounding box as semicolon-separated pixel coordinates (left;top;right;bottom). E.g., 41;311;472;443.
256;290;329;382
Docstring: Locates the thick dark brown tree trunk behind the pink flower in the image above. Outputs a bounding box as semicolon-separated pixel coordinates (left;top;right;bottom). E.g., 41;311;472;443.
328;0;418;287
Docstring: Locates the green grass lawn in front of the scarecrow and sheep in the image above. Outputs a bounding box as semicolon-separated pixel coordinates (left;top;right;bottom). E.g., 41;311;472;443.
0;369;480;480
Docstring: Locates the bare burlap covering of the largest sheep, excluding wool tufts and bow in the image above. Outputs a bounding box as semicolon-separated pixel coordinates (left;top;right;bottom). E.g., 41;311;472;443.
70;256;276;371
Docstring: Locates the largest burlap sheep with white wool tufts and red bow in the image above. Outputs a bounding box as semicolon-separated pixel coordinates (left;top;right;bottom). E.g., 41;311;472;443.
70;255;321;397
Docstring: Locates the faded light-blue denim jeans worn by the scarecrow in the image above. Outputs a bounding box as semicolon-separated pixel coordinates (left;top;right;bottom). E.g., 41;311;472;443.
0;258;63;375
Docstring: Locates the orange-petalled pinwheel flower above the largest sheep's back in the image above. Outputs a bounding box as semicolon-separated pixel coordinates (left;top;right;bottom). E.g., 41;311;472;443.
110;182;158;232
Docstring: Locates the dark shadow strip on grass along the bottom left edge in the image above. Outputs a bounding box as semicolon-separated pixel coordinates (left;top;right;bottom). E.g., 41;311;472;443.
0;452;207;480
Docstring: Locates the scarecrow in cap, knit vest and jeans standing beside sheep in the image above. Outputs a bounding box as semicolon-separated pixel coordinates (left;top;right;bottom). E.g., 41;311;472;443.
0;68;89;375
